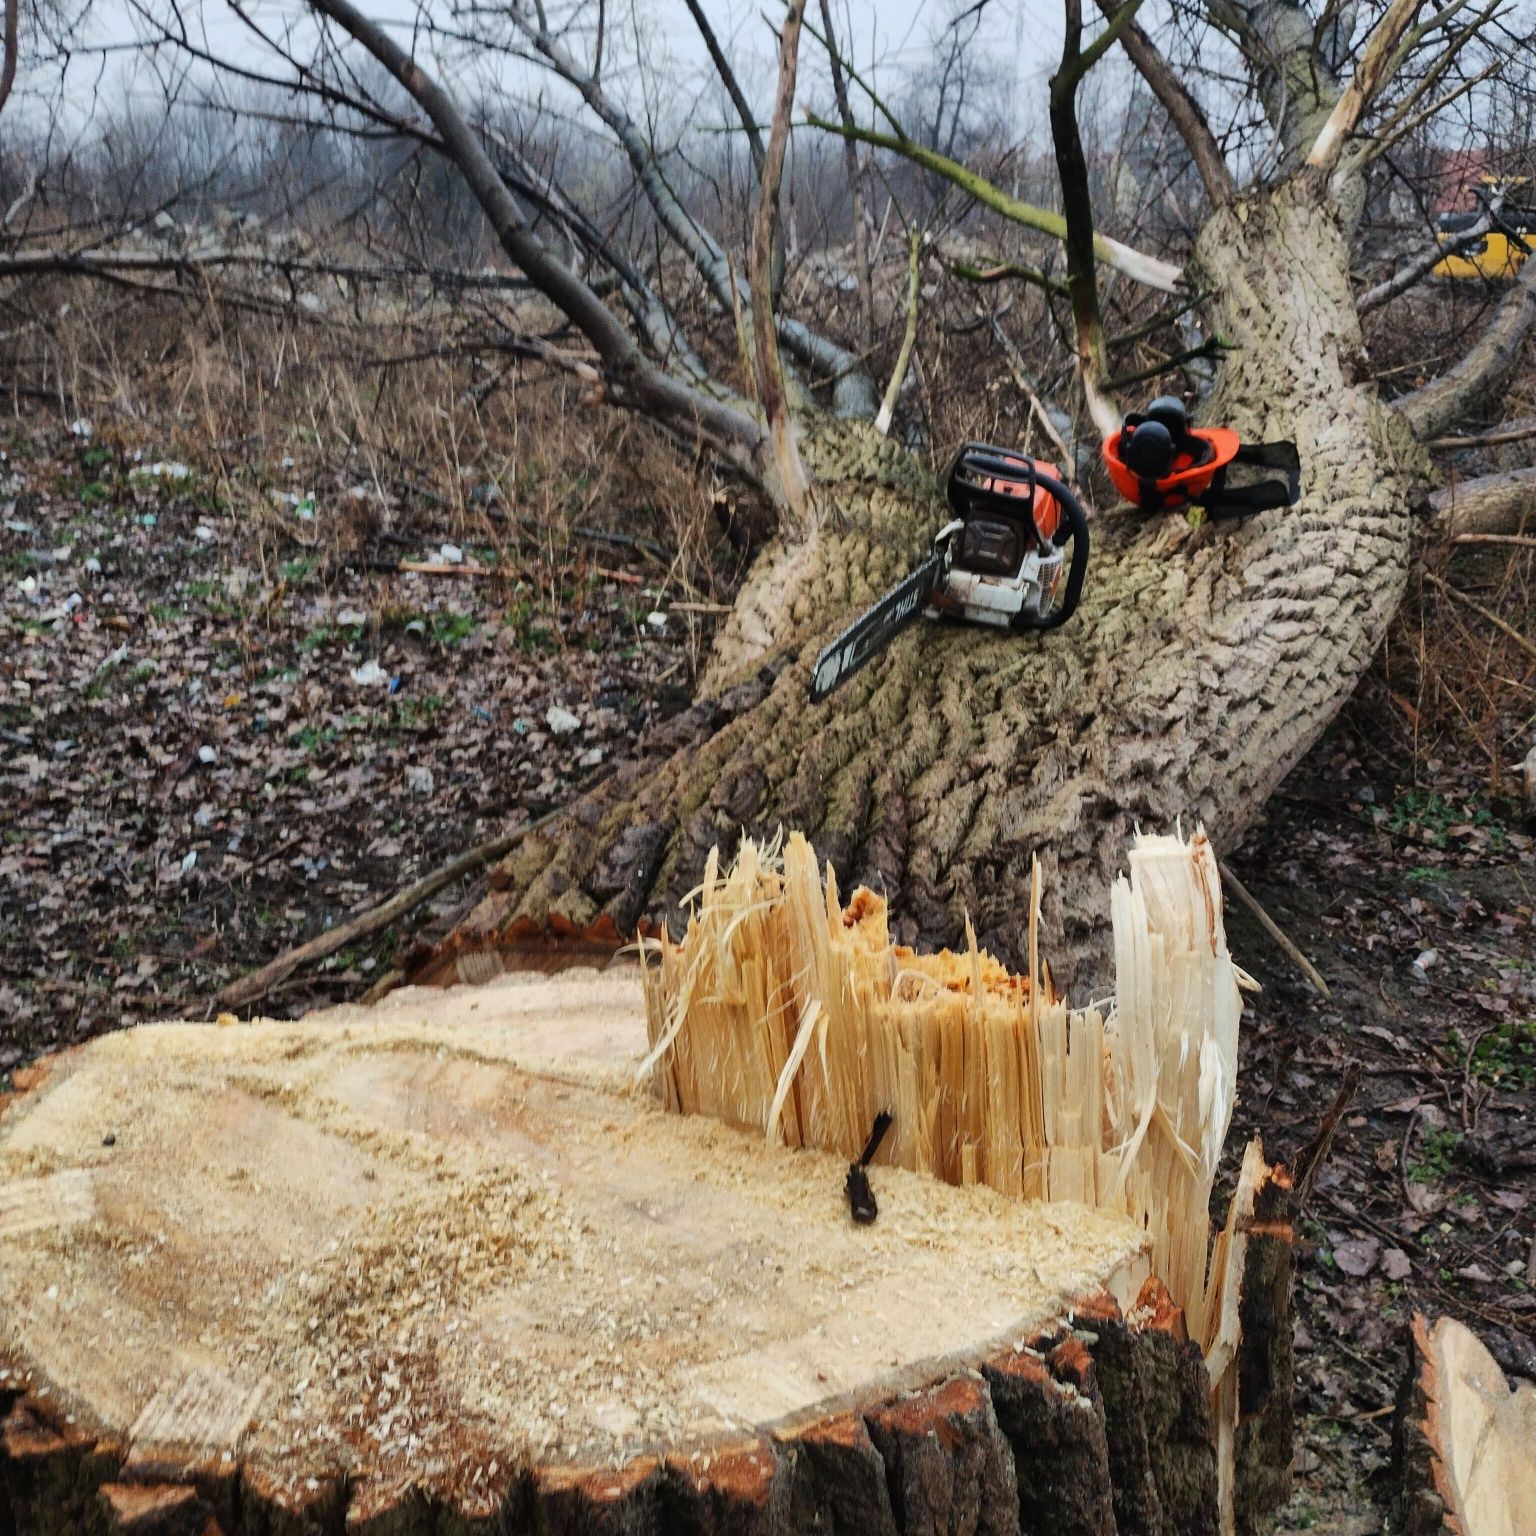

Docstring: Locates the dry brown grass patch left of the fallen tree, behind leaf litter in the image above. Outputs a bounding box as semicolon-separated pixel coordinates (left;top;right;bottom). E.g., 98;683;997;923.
0;265;740;621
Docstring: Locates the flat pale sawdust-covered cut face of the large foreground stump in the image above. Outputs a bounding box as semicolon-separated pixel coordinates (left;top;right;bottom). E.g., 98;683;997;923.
0;969;1147;1528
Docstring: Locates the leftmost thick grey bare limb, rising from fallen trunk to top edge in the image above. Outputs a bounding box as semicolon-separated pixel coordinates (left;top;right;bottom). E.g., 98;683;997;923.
310;0;763;472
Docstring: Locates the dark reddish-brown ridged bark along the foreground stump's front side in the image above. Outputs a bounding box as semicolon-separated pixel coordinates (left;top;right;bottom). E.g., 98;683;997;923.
0;1283;1289;1536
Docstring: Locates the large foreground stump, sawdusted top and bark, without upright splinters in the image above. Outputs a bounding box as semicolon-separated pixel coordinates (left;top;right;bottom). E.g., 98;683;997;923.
0;969;1241;1536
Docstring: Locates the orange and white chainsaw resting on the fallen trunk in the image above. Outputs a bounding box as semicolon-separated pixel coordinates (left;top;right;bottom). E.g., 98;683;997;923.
811;442;1087;702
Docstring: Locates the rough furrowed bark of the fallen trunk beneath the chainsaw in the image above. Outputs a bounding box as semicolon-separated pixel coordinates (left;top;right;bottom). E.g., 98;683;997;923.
421;181;1430;980
